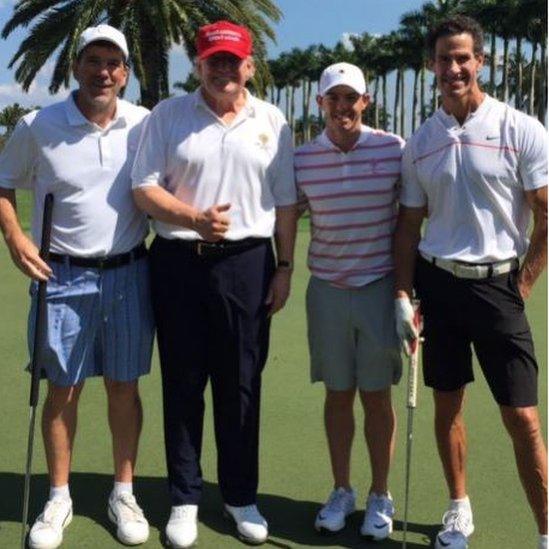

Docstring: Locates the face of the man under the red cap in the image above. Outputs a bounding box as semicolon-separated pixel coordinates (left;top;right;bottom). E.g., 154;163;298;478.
197;52;255;100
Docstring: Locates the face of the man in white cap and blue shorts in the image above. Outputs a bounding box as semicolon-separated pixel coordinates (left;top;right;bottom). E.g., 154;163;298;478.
73;44;128;114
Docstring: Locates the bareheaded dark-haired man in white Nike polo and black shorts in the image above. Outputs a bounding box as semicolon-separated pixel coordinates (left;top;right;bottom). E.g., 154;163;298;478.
394;16;547;548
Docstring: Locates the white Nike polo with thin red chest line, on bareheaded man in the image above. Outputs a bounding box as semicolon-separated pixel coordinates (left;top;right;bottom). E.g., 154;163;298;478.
400;95;548;263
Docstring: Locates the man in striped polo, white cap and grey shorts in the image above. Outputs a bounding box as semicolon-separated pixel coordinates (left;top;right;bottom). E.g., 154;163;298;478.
295;63;403;540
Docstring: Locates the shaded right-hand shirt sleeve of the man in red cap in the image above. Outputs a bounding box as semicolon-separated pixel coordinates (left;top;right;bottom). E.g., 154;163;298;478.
269;117;297;206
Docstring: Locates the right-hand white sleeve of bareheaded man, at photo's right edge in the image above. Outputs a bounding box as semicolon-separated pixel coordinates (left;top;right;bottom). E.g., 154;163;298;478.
518;115;549;191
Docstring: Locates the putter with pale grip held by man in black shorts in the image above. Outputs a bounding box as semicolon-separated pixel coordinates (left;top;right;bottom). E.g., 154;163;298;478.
402;299;423;549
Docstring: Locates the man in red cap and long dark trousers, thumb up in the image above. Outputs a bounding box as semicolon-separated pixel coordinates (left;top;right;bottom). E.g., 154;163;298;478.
132;21;296;547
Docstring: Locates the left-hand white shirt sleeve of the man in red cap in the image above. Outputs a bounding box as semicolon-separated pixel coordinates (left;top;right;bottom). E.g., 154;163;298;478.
131;105;169;189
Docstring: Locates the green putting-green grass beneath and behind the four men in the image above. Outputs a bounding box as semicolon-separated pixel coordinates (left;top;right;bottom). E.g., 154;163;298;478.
0;200;547;549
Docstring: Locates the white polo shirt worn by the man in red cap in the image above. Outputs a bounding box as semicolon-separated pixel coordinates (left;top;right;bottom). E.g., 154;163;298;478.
132;89;296;240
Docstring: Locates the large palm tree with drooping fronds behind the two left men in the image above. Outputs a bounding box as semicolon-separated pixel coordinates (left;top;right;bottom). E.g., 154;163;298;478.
2;0;281;108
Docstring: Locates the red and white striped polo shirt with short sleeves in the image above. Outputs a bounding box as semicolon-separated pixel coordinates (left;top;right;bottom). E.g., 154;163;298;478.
294;126;404;287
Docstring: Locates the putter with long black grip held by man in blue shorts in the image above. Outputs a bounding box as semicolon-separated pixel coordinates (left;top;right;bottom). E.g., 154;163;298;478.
21;193;53;549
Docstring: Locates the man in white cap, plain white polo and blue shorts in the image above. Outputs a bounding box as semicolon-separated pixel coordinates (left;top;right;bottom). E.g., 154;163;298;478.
0;25;154;549
